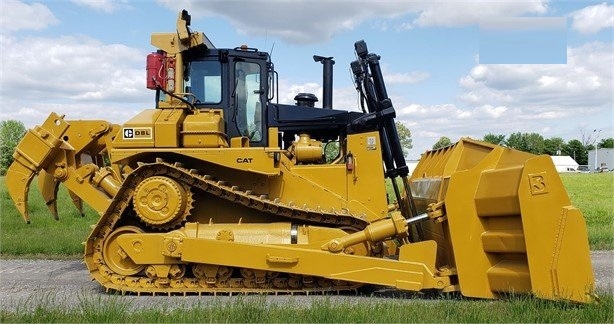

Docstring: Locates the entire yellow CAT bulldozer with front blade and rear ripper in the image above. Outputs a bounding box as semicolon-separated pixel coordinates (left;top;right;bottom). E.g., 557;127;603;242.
6;11;594;302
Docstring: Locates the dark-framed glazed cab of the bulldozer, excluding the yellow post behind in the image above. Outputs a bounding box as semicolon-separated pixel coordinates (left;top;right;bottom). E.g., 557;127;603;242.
184;47;272;146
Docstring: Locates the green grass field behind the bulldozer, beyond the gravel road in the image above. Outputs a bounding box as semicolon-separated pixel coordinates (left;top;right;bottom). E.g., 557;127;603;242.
0;172;614;258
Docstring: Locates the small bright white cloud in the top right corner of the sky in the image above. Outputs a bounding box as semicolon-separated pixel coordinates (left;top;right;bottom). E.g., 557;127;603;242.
570;2;614;34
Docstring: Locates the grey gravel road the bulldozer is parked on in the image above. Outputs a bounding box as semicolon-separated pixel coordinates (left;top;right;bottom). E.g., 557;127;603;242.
0;251;614;311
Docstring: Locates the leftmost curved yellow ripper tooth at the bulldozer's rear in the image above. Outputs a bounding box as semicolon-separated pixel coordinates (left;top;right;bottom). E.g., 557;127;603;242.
5;157;36;224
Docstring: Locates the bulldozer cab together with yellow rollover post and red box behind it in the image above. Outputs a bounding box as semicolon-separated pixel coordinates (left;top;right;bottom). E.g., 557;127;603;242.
147;10;275;147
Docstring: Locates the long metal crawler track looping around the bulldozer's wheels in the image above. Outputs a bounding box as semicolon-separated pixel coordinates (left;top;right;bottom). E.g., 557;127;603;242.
85;159;367;295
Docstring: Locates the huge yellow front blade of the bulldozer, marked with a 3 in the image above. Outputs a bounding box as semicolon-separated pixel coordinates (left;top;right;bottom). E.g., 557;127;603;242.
411;139;594;303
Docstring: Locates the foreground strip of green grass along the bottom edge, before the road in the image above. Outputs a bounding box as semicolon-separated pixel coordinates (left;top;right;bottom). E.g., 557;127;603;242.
0;294;613;323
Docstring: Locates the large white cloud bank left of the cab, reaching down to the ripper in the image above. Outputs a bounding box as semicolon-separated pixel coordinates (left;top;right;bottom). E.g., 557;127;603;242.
0;36;153;126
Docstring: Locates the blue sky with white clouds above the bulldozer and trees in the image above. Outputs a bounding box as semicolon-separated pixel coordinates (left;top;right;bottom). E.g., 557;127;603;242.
0;0;614;159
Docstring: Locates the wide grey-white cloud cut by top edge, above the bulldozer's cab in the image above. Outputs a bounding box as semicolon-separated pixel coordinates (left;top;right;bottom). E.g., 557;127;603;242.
158;0;405;43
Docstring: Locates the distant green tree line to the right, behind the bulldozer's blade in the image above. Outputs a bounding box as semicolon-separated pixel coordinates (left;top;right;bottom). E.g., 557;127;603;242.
433;132;614;165
